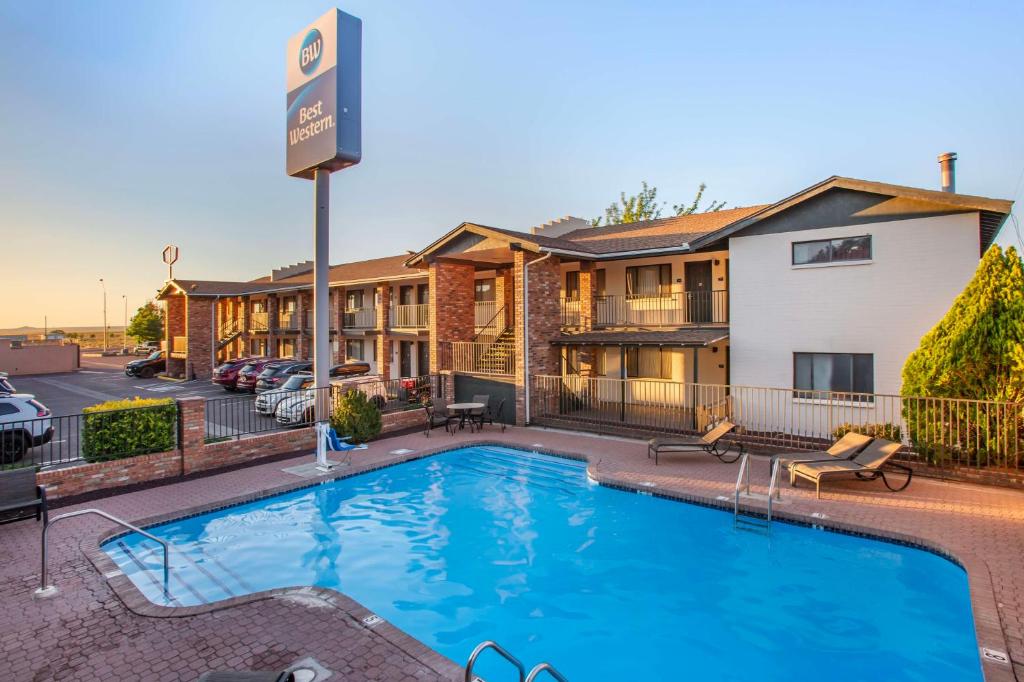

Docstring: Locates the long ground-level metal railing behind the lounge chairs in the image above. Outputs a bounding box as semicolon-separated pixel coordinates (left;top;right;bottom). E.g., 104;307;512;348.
530;376;1024;470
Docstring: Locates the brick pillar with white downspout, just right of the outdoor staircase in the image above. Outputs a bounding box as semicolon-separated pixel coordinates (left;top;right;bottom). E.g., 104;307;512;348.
514;246;562;426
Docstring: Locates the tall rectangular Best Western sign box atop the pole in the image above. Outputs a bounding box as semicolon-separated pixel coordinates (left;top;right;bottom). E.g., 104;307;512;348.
285;9;362;178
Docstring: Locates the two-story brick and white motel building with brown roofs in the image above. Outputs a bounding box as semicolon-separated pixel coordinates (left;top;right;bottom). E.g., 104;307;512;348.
160;168;1012;423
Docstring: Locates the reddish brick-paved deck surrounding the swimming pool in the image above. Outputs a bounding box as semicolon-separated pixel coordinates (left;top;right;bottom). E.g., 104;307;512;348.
0;427;1024;682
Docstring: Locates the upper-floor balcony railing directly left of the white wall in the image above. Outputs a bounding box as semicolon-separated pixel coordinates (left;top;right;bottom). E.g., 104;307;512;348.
561;291;729;328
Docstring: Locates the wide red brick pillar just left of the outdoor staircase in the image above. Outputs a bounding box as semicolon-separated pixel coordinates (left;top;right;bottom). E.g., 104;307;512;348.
428;261;475;374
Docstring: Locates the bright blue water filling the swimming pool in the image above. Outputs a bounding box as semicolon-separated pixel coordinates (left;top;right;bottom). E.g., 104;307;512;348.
103;446;981;682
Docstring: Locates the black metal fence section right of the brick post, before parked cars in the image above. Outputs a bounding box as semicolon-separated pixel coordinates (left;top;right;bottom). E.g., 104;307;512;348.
206;375;444;442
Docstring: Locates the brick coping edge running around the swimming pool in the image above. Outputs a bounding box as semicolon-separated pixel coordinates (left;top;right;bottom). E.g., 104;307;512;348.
81;439;1017;682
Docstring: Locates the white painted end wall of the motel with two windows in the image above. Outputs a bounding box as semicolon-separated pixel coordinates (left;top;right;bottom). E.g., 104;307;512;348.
729;213;979;393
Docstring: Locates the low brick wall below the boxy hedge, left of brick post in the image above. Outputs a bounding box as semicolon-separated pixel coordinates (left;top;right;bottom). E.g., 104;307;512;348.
36;450;181;499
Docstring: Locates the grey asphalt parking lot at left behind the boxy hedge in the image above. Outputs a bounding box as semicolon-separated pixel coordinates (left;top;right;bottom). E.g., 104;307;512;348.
0;356;292;466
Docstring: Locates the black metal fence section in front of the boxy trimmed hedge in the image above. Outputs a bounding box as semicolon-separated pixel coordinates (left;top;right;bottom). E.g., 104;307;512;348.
0;400;179;469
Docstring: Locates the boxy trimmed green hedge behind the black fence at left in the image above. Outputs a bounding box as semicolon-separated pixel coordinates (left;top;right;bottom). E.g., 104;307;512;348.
82;398;178;462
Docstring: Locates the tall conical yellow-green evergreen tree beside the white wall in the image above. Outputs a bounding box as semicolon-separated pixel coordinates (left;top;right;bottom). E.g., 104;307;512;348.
902;246;1024;465
